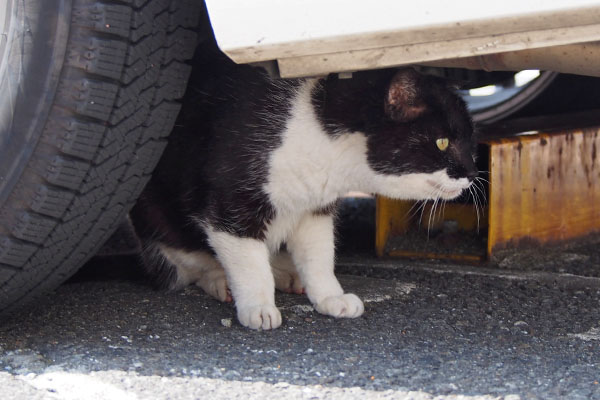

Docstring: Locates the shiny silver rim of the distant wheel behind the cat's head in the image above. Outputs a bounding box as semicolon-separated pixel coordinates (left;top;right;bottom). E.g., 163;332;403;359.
461;71;558;124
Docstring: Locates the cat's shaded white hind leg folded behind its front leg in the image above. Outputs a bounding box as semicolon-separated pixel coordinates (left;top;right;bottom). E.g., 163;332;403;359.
158;245;232;302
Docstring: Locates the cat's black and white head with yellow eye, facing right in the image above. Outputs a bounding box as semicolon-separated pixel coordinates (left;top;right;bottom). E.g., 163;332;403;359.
364;68;477;200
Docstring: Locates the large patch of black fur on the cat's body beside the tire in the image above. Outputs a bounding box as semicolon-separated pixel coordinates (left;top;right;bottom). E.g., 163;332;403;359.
132;43;301;250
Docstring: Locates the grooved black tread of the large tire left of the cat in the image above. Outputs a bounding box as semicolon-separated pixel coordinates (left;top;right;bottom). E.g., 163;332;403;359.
0;0;200;316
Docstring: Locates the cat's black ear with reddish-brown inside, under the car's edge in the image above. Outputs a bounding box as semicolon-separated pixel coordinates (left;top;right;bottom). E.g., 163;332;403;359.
385;68;427;122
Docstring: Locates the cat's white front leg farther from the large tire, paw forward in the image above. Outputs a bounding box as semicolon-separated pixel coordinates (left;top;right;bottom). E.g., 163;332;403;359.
287;214;364;318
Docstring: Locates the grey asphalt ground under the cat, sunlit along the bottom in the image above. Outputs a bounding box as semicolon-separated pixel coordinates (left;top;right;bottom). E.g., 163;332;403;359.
0;259;600;400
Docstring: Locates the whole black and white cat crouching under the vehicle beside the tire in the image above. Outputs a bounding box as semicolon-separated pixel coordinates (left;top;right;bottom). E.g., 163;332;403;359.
131;44;477;329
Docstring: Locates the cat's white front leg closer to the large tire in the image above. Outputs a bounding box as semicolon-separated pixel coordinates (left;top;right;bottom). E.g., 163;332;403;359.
207;229;281;329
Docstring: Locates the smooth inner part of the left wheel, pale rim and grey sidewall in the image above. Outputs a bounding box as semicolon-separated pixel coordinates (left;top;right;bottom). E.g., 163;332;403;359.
0;0;71;205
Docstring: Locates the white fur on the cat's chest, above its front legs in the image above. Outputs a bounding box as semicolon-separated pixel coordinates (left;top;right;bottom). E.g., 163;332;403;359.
264;81;368;219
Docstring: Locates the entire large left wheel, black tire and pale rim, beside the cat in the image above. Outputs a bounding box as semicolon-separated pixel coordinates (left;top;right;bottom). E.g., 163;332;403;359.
0;0;201;316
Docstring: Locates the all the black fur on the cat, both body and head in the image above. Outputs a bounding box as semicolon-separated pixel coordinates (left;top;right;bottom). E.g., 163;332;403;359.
131;36;476;287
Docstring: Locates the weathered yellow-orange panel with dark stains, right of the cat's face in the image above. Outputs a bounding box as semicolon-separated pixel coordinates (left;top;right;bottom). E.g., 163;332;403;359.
488;128;600;255
